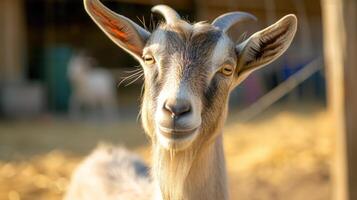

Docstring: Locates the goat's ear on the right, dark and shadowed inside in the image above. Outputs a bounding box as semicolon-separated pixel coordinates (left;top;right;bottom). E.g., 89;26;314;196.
236;14;297;81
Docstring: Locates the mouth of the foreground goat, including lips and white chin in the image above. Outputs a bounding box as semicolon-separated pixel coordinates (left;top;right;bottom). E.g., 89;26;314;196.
157;126;200;150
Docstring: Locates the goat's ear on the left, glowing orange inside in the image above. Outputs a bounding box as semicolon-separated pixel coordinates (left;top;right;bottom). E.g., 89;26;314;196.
84;0;150;61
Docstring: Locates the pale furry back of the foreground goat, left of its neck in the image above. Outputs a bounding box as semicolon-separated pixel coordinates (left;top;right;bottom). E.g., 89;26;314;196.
64;147;153;200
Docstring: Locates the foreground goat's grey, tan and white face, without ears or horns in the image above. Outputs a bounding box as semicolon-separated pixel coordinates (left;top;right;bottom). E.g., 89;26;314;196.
143;22;237;150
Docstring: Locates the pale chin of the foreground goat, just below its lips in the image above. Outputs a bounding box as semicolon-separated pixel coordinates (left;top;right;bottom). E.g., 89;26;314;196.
156;128;199;151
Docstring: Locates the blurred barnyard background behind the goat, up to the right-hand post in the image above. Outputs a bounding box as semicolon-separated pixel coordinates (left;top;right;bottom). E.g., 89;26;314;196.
0;0;355;200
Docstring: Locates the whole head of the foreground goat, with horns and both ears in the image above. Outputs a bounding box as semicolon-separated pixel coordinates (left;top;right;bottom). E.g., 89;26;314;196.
84;0;297;150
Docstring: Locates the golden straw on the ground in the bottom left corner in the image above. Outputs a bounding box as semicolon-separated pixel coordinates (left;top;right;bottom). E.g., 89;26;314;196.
0;151;80;200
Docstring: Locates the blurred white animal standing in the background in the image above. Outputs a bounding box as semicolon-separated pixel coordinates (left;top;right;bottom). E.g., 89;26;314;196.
68;52;117;119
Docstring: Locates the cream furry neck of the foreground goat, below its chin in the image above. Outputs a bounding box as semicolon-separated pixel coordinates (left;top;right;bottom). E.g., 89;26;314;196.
153;134;228;200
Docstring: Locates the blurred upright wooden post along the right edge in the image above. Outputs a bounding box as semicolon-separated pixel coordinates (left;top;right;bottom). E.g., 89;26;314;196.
321;0;357;200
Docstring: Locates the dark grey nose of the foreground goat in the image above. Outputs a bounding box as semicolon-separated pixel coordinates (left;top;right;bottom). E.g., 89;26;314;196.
164;99;191;117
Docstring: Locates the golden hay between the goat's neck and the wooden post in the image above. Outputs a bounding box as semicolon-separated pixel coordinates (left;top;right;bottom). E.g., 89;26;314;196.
225;112;334;200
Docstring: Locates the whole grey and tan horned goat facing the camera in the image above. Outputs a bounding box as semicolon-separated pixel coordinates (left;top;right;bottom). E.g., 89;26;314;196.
66;0;297;200
